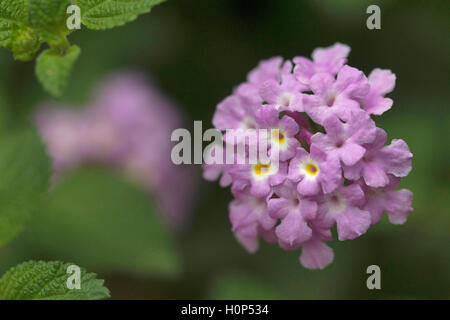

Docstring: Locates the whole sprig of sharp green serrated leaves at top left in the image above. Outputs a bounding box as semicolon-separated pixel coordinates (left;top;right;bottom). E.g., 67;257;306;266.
0;0;164;96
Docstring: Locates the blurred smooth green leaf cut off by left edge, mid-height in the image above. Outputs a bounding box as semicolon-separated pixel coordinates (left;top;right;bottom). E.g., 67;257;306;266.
0;131;50;246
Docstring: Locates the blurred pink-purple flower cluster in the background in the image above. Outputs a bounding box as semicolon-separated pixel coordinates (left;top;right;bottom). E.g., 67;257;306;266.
36;73;197;228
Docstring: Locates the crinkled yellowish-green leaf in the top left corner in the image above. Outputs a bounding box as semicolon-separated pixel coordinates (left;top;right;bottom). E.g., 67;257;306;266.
0;0;41;61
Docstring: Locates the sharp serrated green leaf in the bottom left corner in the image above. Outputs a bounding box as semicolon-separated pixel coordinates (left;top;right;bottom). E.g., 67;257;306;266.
0;261;110;300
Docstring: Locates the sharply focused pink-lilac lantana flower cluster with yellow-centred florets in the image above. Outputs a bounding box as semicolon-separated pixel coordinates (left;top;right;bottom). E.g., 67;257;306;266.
204;43;413;269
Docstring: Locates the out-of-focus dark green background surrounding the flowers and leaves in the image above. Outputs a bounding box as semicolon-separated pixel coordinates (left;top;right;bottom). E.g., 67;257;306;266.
0;0;450;299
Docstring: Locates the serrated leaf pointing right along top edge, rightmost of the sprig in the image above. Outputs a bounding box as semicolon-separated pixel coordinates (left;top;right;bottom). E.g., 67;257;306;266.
76;0;164;30
